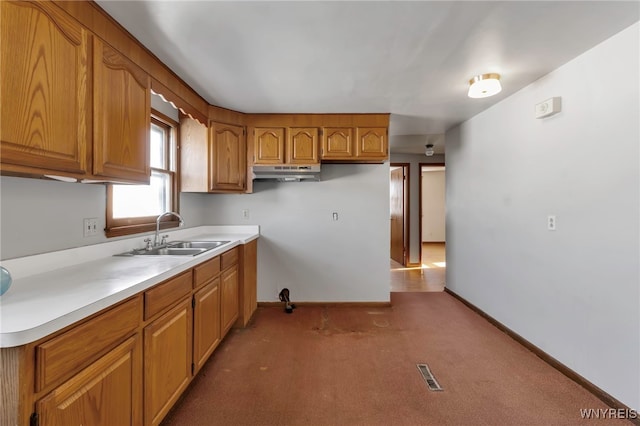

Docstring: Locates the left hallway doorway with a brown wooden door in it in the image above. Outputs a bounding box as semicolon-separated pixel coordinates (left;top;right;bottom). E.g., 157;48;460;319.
389;163;409;266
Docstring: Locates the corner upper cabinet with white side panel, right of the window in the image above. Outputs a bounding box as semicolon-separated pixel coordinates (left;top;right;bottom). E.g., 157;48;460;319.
180;115;247;193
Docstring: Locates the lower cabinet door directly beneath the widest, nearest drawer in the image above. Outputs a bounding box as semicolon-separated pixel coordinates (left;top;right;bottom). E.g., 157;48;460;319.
36;335;142;426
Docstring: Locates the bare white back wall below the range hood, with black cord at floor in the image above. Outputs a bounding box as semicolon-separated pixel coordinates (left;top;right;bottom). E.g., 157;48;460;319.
200;164;390;302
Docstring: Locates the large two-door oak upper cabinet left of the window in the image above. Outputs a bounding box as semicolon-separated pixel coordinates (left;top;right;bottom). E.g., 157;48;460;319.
0;1;151;183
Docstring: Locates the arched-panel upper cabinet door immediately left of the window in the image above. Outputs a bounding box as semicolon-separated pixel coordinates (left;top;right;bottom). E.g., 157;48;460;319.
93;37;151;183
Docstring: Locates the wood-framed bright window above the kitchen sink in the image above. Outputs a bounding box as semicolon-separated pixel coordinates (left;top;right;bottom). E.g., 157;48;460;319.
107;110;178;237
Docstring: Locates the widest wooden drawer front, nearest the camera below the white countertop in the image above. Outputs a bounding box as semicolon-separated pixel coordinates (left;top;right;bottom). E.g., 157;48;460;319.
36;297;142;391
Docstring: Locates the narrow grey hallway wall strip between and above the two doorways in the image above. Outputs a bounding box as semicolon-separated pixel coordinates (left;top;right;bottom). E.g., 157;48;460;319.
389;154;445;264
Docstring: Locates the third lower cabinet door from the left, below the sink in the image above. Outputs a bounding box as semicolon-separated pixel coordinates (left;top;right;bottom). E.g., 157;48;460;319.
193;278;220;374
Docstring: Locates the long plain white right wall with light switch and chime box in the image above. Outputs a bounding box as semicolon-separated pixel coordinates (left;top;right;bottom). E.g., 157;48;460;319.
446;23;640;409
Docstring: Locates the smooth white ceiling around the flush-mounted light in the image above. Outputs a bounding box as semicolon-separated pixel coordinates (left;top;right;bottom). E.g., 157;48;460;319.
96;0;640;153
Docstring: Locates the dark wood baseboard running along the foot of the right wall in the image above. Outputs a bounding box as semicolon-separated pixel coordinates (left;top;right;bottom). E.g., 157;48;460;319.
444;287;640;425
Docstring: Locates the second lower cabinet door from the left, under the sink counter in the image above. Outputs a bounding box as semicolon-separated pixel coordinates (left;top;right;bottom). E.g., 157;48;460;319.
145;298;193;425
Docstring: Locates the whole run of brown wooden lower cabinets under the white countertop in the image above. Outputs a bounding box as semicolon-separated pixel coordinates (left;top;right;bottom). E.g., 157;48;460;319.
0;241;257;426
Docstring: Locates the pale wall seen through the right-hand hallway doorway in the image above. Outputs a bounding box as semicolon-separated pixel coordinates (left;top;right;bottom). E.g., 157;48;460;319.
422;170;446;242
